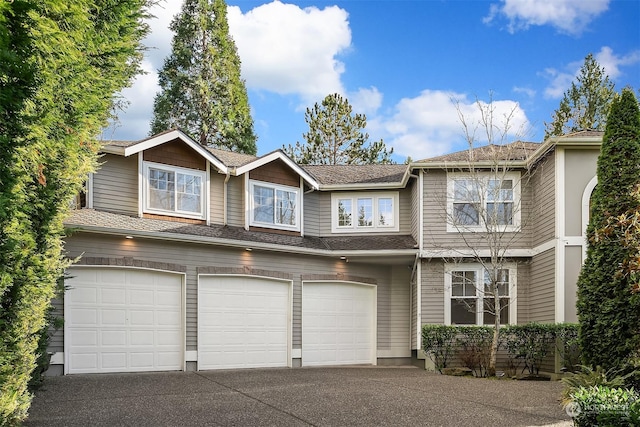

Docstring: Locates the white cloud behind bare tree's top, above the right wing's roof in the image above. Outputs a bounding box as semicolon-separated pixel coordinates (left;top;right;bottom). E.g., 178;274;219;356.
373;90;530;160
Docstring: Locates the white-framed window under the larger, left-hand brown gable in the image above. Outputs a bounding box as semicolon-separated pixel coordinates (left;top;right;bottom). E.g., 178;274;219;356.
144;162;206;218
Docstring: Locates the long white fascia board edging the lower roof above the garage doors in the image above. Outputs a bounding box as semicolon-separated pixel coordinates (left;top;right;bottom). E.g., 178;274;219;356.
65;224;417;258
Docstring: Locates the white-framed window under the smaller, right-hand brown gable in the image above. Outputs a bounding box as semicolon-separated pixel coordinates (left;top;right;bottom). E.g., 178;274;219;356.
249;181;300;231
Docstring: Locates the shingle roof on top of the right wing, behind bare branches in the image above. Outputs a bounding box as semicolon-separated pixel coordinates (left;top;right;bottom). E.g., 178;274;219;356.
418;141;541;163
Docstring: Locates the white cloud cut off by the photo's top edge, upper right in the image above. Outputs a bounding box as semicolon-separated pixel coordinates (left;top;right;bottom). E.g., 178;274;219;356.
484;0;610;35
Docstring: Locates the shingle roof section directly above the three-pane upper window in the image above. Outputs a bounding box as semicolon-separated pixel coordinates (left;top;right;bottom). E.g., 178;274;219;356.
302;165;408;185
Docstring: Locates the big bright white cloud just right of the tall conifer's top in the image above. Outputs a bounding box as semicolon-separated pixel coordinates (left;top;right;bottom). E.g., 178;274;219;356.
228;1;351;101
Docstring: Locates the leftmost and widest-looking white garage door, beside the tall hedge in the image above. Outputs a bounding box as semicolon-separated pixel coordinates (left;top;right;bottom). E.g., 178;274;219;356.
64;267;184;374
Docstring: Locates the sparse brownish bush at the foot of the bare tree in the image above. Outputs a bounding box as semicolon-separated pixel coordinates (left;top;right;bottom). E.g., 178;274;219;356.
456;326;493;377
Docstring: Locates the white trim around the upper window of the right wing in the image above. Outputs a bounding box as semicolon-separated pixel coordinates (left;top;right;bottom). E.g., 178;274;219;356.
447;172;522;233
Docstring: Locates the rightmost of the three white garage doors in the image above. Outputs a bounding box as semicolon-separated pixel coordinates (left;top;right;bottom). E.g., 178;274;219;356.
302;282;376;366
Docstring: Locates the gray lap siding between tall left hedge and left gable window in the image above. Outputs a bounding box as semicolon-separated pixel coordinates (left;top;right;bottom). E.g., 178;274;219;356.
93;154;138;215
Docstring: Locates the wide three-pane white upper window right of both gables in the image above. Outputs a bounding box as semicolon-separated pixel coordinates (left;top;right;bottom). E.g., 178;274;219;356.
331;192;399;233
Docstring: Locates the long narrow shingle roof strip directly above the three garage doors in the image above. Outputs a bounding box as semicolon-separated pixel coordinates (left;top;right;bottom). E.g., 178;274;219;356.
65;209;416;251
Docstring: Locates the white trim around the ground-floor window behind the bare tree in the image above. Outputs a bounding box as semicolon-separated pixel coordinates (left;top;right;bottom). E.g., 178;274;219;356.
444;263;518;326
